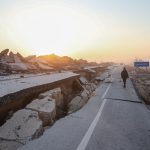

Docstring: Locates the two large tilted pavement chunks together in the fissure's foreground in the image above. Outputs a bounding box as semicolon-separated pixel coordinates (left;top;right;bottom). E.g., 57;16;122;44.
0;88;63;149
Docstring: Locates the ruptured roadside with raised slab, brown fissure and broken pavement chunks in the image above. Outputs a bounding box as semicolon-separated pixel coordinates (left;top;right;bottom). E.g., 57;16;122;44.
0;58;110;150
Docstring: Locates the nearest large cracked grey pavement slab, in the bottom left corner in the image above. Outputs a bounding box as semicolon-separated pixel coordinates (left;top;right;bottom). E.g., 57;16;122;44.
0;109;43;141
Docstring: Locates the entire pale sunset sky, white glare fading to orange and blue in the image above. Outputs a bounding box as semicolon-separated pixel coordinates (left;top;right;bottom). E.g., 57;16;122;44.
0;0;150;62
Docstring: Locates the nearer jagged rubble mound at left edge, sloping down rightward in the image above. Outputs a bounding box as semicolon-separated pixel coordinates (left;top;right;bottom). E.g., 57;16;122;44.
0;49;54;74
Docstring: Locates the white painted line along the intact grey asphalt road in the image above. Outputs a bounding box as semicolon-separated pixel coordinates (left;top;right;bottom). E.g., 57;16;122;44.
77;84;111;150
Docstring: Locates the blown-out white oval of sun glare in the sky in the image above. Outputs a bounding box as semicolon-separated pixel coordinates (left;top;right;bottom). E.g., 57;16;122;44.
6;6;99;55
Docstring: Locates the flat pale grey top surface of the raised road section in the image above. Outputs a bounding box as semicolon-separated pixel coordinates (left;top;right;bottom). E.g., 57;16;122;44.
0;72;78;97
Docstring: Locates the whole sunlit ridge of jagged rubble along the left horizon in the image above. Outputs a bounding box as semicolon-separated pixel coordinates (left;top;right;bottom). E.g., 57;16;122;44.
0;49;103;75
